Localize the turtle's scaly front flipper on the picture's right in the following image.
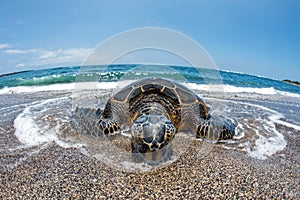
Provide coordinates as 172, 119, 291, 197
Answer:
196, 116, 236, 141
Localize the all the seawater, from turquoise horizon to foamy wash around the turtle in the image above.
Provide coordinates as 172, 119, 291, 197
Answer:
0, 65, 300, 170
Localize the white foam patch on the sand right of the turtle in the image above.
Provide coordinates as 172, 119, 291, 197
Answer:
225, 100, 300, 160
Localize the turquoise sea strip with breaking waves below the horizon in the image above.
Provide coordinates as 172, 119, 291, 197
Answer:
0, 64, 300, 94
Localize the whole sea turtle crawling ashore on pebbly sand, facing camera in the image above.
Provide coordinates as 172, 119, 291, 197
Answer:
74, 77, 235, 161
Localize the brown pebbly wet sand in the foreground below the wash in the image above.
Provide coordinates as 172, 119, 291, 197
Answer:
0, 123, 300, 199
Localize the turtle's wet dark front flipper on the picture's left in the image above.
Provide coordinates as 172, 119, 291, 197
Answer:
73, 108, 120, 137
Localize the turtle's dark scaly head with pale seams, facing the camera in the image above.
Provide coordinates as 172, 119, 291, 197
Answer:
131, 114, 176, 153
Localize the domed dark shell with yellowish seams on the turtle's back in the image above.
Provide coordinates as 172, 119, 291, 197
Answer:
111, 78, 208, 118
